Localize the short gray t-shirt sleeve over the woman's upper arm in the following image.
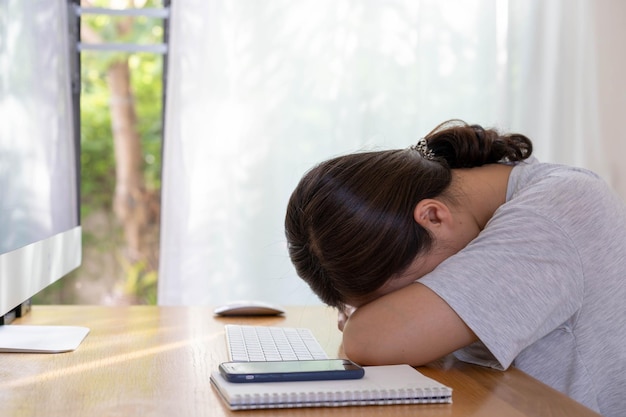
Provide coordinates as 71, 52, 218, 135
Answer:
418, 206, 584, 369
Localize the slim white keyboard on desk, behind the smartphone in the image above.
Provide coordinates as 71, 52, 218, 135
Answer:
224, 324, 328, 362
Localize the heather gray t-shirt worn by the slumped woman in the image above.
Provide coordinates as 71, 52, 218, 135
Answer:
419, 159, 626, 417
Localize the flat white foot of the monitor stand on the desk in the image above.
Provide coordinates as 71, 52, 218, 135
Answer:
0, 324, 89, 353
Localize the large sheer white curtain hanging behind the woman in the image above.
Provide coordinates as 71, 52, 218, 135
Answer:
159, 0, 626, 305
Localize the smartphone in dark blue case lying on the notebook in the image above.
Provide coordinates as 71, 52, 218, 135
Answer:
219, 359, 365, 382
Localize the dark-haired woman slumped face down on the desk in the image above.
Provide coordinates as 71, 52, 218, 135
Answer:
285, 121, 626, 416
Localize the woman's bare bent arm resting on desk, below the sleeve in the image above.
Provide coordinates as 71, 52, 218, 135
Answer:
343, 283, 477, 366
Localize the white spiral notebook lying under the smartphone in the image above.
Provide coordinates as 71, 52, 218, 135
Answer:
211, 365, 452, 410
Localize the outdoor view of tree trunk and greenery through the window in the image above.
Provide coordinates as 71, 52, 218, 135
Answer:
35, 0, 162, 303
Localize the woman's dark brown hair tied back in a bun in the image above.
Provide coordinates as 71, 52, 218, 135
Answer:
285, 120, 532, 308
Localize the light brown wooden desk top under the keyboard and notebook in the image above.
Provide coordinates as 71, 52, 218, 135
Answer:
0, 306, 598, 417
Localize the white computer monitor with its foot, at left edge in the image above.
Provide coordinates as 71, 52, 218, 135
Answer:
0, 0, 88, 351
